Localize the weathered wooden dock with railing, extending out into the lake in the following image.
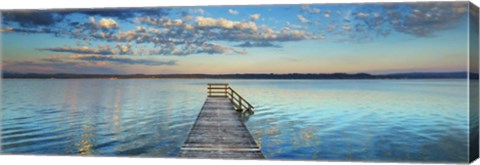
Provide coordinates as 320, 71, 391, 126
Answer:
180, 84, 264, 159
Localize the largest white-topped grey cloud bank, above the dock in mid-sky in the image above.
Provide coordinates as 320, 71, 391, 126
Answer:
104, 16, 309, 44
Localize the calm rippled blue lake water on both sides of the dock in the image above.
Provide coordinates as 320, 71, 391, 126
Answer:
1, 79, 468, 162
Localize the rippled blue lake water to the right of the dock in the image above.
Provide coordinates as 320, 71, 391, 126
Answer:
234, 80, 468, 162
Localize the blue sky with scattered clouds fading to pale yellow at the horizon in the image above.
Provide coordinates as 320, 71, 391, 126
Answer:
0, 2, 478, 74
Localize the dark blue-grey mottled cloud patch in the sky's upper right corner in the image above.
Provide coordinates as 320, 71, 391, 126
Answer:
355, 2, 468, 37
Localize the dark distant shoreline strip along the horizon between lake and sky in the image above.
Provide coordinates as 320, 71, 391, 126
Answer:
2, 72, 478, 80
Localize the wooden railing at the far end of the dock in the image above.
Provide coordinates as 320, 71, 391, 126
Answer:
207, 83, 254, 112
